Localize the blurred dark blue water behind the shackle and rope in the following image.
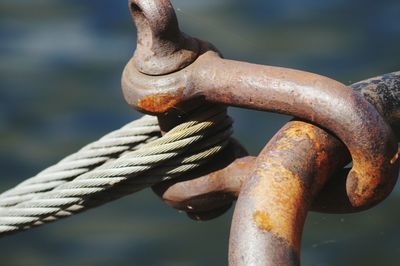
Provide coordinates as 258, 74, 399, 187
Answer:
0, 0, 400, 266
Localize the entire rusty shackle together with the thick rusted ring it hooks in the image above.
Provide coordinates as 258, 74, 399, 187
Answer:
122, 0, 400, 265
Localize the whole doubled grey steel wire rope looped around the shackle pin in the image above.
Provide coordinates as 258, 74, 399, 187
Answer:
0, 106, 232, 235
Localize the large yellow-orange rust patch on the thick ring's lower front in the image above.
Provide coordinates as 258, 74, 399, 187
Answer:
250, 163, 307, 250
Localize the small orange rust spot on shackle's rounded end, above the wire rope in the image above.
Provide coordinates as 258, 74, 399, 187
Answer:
137, 93, 181, 113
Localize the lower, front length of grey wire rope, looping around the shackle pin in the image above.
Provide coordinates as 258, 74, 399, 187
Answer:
0, 107, 232, 234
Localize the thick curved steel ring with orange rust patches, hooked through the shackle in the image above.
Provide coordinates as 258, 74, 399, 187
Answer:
229, 73, 400, 265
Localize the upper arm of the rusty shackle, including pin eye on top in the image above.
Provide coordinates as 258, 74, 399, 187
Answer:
122, 0, 398, 207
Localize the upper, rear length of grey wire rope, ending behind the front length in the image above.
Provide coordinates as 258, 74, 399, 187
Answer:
0, 116, 160, 207
